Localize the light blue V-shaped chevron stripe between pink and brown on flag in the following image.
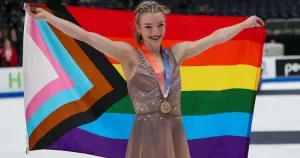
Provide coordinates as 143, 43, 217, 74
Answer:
27, 20, 92, 136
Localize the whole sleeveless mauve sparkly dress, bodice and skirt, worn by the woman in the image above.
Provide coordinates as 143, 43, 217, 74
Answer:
126, 49, 190, 158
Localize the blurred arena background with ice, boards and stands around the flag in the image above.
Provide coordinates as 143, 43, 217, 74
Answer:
0, 0, 300, 158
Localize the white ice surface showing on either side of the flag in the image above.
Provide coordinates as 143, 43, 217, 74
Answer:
0, 95, 300, 158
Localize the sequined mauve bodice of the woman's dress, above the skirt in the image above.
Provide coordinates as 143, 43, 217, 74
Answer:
127, 49, 181, 118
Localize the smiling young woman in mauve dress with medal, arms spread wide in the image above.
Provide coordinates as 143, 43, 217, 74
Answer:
25, 1, 264, 158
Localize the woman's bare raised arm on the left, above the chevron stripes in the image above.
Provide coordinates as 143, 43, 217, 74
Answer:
25, 5, 136, 65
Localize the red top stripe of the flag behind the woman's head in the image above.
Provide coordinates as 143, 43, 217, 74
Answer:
67, 6, 266, 42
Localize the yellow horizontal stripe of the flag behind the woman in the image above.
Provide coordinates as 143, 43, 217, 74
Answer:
114, 64, 260, 91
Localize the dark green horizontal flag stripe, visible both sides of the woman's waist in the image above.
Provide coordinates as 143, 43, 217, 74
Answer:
106, 89, 255, 116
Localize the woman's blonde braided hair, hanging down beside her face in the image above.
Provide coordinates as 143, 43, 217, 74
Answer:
133, 1, 164, 45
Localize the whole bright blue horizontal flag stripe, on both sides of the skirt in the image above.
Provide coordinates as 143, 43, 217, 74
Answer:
79, 113, 252, 140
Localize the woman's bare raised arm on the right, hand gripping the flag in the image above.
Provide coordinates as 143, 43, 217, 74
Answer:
172, 16, 264, 63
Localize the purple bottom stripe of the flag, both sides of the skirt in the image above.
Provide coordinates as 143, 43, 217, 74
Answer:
49, 129, 249, 158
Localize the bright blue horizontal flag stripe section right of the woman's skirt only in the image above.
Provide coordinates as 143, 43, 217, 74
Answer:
183, 112, 252, 140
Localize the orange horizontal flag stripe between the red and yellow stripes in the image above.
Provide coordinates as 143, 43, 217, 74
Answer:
105, 37, 263, 67
